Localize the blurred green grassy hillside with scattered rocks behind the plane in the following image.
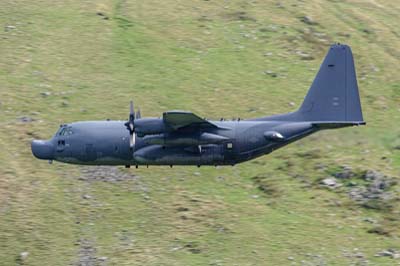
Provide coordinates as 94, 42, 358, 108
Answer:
0, 0, 400, 266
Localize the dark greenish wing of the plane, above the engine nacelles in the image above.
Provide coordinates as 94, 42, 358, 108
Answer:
163, 111, 217, 130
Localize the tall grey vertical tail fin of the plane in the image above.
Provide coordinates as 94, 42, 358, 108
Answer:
294, 44, 365, 124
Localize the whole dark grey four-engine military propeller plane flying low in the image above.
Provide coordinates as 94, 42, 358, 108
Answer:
31, 44, 365, 167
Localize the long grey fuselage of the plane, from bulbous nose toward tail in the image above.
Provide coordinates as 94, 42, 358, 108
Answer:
32, 120, 318, 166
